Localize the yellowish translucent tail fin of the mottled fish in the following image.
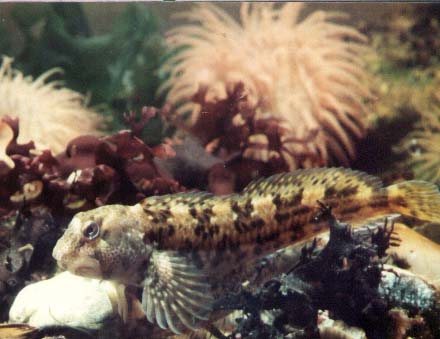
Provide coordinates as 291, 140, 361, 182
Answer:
386, 180, 440, 222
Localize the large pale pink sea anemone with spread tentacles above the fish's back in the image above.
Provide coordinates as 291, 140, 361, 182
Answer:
161, 3, 371, 169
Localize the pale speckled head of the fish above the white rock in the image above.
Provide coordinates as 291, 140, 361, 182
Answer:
53, 205, 152, 283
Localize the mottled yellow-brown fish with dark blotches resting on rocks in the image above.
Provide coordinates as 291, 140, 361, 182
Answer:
53, 168, 440, 333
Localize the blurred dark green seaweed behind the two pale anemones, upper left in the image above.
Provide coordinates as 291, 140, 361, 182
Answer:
0, 3, 165, 130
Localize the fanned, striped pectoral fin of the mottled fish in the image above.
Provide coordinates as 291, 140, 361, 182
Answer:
142, 251, 214, 334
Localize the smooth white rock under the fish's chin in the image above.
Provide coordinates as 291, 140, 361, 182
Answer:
9, 272, 124, 330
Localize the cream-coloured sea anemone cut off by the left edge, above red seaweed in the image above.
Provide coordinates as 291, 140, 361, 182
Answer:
0, 57, 101, 159
